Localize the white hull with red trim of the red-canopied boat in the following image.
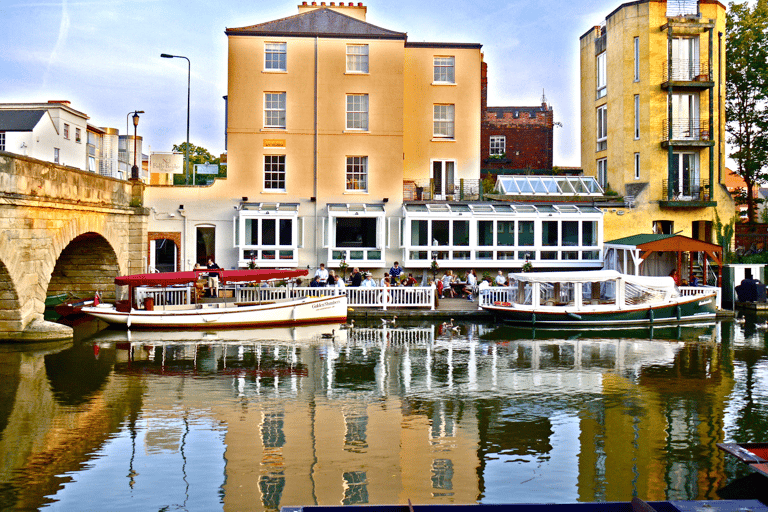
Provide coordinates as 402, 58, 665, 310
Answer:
82, 295, 347, 329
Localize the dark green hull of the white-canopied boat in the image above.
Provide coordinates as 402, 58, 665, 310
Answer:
483, 294, 717, 329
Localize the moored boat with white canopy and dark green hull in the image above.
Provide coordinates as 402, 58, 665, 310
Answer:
480, 270, 717, 329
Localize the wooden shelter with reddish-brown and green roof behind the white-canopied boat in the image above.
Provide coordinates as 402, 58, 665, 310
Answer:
604, 234, 723, 286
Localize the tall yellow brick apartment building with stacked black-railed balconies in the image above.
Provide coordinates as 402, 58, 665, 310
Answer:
580, 0, 734, 246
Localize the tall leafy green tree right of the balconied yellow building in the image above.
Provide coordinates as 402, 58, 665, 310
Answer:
725, 0, 768, 222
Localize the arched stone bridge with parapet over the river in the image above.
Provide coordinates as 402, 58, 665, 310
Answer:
0, 151, 148, 340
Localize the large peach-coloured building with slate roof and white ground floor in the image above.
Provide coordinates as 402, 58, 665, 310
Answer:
148, 2, 482, 269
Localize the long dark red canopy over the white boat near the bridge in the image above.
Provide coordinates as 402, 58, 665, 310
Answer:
115, 269, 309, 286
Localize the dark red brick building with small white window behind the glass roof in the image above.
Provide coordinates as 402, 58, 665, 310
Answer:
480, 63, 554, 174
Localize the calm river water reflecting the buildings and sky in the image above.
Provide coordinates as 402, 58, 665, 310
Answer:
0, 322, 768, 511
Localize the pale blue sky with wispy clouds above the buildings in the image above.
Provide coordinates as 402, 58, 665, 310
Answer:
0, 0, 622, 166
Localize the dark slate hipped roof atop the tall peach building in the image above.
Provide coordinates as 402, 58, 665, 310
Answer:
224, 7, 408, 40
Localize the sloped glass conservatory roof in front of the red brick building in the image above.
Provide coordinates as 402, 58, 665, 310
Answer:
496, 175, 603, 197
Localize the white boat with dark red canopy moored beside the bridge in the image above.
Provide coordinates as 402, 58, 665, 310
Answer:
81, 269, 347, 329
